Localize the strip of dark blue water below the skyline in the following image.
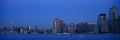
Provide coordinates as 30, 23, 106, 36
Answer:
0, 34, 120, 40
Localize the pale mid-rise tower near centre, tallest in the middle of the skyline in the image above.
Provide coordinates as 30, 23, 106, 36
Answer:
53, 18, 64, 33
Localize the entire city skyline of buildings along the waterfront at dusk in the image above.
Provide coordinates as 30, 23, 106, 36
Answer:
0, 6, 120, 34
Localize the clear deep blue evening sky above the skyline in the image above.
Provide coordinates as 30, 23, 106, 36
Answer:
0, 0, 120, 27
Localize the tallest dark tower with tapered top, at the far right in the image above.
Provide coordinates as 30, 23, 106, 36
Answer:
108, 6, 119, 33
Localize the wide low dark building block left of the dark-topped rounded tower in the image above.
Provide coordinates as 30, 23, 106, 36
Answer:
76, 22, 98, 34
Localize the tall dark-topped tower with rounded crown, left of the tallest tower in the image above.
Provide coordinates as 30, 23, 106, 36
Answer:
97, 13, 109, 33
